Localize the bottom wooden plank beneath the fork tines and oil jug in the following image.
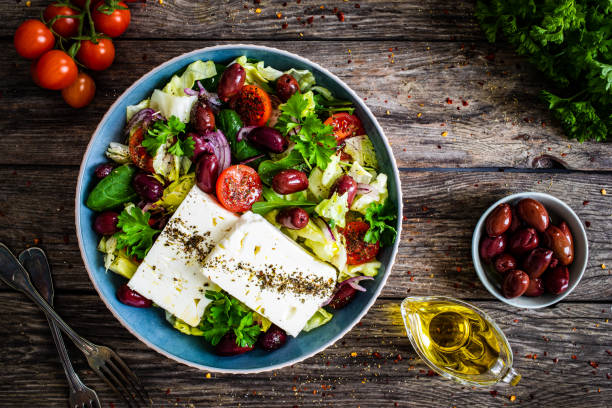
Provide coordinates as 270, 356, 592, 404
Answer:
0, 293, 612, 408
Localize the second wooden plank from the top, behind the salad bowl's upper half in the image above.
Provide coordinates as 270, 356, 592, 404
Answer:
0, 41, 612, 170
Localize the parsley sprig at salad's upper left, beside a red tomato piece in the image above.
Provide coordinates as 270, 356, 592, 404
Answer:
142, 115, 195, 157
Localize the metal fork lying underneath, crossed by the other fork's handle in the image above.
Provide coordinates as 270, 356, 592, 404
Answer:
19, 247, 102, 408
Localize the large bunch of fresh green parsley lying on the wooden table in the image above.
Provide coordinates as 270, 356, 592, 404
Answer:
475, 0, 612, 142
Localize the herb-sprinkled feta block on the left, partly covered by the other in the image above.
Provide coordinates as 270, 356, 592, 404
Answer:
128, 186, 239, 326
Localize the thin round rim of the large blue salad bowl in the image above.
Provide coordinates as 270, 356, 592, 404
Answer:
74, 44, 403, 374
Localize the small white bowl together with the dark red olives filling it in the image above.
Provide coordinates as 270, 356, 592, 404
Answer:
472, 192, 588, 308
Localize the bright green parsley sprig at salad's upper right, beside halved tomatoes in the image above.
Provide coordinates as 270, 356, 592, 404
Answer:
276, 92, 337, 169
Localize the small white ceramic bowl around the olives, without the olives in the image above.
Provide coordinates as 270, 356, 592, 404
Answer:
472, 192, 589, 309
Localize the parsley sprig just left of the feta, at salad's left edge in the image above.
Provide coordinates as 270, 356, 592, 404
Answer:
115, 204, 161, 259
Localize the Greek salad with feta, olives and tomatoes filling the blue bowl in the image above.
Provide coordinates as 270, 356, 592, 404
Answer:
86, 56, 396, 356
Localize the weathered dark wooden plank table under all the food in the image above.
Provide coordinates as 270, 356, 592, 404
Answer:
0, 0, 612, 407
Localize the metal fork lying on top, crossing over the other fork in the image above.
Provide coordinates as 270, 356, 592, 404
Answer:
0, 243, 151, 408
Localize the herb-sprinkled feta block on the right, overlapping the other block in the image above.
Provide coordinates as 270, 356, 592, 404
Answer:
202, 212, 336, 336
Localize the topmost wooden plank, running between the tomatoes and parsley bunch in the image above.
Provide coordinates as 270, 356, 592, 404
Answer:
0, 0, 483, 41
